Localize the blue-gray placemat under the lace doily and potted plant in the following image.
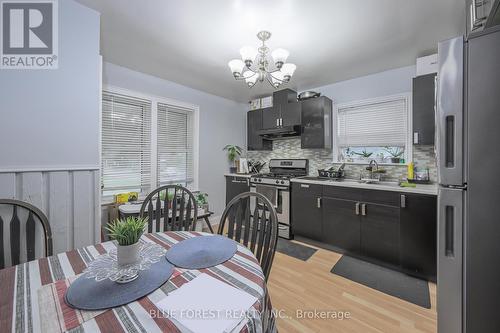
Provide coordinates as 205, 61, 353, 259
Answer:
64, 258, 174, 310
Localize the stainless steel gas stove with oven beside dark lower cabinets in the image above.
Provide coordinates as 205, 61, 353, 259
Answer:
250, 159, 309, 239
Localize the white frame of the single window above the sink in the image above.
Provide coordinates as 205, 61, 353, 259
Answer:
332, 92, 413, 165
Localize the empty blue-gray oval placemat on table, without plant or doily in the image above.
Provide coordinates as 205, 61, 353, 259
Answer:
166, 235, 237, 269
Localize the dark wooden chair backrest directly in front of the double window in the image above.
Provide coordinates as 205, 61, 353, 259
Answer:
139, 185, 198, 232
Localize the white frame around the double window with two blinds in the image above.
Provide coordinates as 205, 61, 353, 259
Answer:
99, 85, 200, 202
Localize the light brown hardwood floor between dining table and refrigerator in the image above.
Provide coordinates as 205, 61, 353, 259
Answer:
268, 239, 437, 333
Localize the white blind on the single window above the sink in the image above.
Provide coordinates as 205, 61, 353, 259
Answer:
337, 97, 408, 147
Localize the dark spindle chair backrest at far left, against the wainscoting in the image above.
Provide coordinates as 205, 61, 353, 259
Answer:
0, 199, 52, 269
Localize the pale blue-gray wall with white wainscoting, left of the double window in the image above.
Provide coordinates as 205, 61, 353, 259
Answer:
0, 0, 101, 253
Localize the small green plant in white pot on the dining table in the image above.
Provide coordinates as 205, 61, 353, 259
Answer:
106, 216, 148, 265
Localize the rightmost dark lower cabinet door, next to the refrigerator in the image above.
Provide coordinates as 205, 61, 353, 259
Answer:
400, 193, 437, 281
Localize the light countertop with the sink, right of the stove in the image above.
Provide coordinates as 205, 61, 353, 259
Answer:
291, 178, 438, 195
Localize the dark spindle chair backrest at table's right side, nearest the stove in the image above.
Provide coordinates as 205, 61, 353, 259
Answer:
218, 192, 278, 280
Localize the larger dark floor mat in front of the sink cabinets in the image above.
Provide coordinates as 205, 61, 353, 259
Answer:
331, 256, 431, 309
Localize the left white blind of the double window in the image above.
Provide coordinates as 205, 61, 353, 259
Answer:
101, 91, 151, 194
